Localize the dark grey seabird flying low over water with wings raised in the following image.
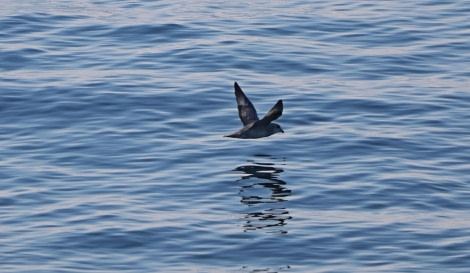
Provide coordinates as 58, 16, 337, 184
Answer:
226, 82, 284, 138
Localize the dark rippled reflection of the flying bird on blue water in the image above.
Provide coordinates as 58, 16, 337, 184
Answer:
235, 155, 292, 233
